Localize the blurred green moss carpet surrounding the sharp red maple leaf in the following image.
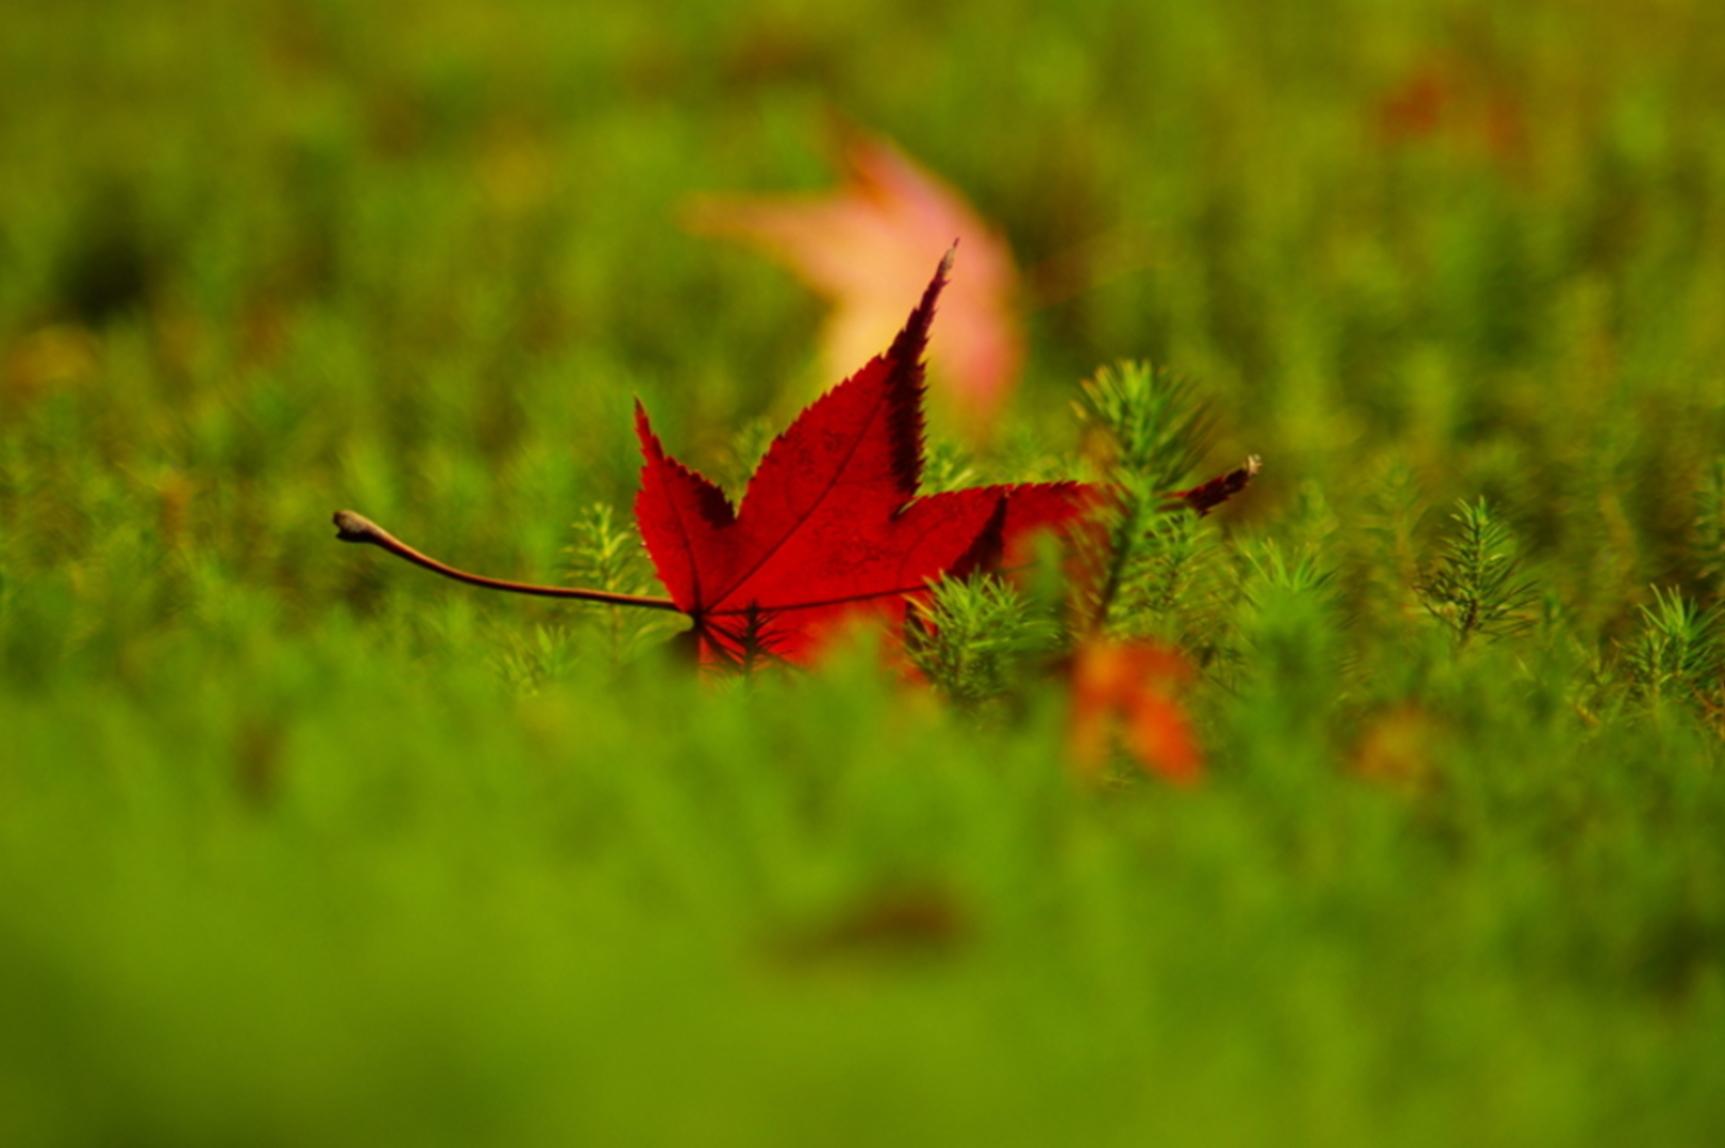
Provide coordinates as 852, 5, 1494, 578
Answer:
0, 0, 1725, 1145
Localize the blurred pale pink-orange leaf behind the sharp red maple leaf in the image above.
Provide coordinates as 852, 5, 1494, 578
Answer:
688, 134, 1025, 440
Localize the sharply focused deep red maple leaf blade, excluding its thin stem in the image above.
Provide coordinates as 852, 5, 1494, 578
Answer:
635, 252, 1092, 664
